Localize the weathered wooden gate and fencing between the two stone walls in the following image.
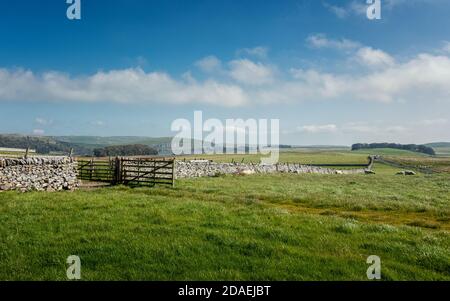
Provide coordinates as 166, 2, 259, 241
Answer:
78, 157, 175, 186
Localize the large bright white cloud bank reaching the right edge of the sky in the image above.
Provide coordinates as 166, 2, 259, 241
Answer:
284, 54, 450, 102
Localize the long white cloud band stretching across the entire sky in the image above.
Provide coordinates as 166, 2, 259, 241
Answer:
0, 48, 450, 107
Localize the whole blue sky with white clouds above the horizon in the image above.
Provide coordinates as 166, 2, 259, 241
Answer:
0, 0, 450, 145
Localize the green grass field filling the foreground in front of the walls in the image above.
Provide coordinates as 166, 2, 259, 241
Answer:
0, 164, 450, 280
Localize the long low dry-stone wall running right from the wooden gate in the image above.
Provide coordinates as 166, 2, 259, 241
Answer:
175, 161, 370, 178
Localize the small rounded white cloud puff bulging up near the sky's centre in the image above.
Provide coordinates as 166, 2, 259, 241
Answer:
229, 59, 274, 85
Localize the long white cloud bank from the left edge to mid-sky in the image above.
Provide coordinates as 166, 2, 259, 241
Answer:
0, 68, 248, 106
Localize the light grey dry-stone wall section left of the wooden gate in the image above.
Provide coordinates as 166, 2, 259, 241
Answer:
0, 157, 79, 192
